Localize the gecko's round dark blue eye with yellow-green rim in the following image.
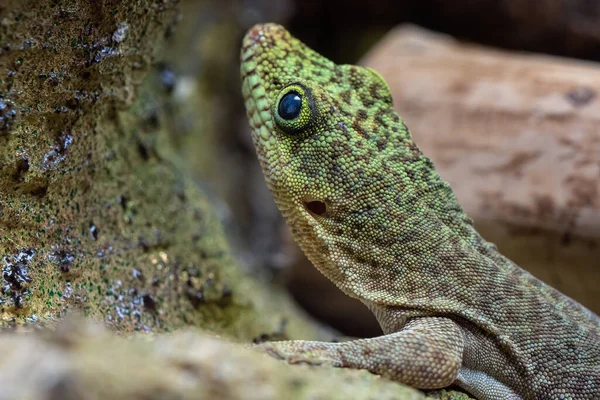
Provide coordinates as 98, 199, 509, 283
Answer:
273, 83, 315, 135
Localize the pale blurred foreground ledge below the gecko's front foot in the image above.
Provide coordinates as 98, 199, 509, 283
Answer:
0, 323, 432, 400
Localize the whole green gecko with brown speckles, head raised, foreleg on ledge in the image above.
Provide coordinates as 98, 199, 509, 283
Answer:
241, 24, 600, 400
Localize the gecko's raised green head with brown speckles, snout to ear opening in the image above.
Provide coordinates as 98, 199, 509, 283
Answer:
241, 24, 418, 297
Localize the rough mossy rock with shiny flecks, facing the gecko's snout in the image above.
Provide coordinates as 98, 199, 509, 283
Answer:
0, 0, 316, 340
